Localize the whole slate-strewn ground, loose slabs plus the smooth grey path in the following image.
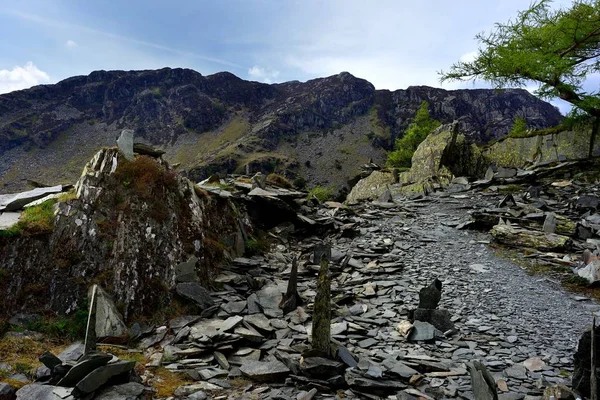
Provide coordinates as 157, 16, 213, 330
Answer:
137, 193, 600, 400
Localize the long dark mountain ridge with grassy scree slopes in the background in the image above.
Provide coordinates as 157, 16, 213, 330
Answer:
0, 68, 560, 192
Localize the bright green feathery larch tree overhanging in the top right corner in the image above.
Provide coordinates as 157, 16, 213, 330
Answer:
440, 0, 600, 151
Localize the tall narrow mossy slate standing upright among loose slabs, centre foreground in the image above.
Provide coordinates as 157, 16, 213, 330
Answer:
311, 257, 331, 354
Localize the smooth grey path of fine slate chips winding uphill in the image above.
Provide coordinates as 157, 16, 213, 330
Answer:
336, 194, 600, 398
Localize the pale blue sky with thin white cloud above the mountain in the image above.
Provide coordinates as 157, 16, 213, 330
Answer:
0, 0, 584, 110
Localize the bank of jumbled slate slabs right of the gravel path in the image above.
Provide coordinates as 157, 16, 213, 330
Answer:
451, 162, 600, 284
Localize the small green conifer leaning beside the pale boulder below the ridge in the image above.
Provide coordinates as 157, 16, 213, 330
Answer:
386, 101, 441, 168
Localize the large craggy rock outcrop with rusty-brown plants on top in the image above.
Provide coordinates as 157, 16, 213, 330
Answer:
0, 148, 249, 318
